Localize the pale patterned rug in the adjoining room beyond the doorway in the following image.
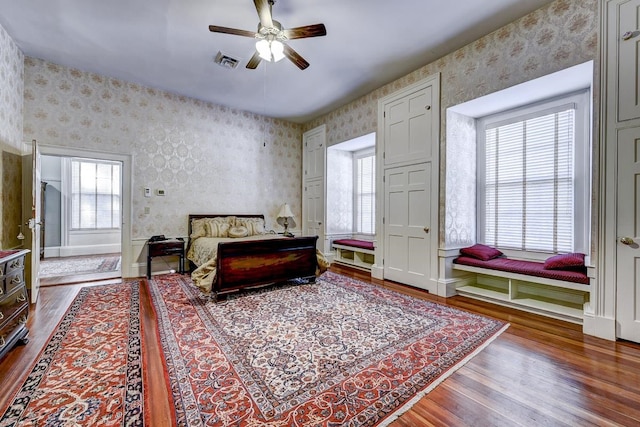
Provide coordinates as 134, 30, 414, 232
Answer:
40, 254, 120, 277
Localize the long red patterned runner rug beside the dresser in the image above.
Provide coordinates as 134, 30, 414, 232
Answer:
0, 281, 144, 426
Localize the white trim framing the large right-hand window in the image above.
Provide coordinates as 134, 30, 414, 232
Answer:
476, 89, 591, 259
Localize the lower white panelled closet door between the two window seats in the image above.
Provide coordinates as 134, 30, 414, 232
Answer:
383, 163, 437, 293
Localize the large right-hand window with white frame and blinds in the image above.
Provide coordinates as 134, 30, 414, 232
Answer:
477, 91, 590, 253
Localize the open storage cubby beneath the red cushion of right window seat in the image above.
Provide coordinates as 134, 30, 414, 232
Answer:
454, 265, 590, 324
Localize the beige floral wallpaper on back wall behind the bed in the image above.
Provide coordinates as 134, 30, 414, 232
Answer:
24, 57, 302, 239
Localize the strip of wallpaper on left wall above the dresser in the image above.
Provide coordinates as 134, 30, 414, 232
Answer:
0, 22, 24, 249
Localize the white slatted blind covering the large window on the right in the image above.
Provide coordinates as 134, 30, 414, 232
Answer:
484, 105, 575, 252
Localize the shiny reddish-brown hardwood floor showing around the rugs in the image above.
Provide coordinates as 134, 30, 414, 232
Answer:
0, 266, 640, 427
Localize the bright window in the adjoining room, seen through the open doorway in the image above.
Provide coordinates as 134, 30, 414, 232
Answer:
71, 159, 121, 230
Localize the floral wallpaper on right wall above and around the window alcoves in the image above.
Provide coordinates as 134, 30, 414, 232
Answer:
304, 0, 600, 248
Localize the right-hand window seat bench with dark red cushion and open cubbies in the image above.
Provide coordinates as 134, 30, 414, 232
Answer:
453, 256, 591, 324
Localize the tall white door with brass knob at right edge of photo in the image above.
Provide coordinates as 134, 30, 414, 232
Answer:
616, 128, 640, 342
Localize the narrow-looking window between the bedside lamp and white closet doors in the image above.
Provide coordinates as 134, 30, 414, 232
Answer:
354, 149, 376, 234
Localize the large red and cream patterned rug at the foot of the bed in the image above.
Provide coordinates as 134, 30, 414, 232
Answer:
149, 272, 508, 427
